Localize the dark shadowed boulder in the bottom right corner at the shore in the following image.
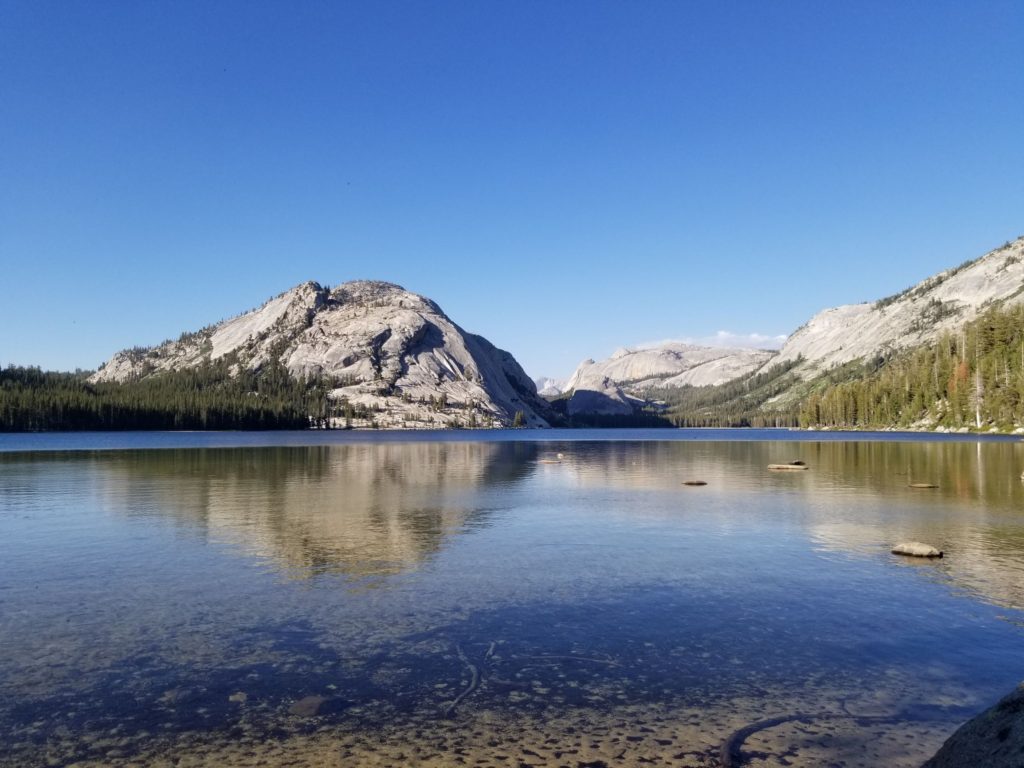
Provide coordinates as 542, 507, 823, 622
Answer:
922, 683, 1024, 768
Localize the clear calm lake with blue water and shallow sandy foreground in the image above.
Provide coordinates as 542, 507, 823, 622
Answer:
0, 430, 1024, 768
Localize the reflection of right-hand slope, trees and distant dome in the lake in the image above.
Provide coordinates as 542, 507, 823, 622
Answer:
528, 441, 1024, 609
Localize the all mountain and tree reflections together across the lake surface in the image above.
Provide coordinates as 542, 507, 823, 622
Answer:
29, 441, 1024, 608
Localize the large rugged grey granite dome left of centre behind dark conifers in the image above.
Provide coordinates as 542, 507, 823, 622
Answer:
91, 281, 548, 428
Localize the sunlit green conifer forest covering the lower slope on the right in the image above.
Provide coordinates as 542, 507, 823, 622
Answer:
622, 304, 1024, 431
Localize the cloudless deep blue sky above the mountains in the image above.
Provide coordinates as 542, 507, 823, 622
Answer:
0, 0, 1024, 376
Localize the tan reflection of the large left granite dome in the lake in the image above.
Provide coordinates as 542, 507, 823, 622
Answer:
96, 443, 536, 579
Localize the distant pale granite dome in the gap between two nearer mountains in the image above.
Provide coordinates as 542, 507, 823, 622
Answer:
562, 342, 775, 416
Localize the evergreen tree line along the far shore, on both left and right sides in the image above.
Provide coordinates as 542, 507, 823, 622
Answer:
8, 304, 1024, 431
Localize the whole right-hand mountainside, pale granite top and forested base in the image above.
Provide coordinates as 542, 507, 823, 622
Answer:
664, 238, 1024, 431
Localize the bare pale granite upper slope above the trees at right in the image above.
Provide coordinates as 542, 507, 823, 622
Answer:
771, 238, 1024, 378
